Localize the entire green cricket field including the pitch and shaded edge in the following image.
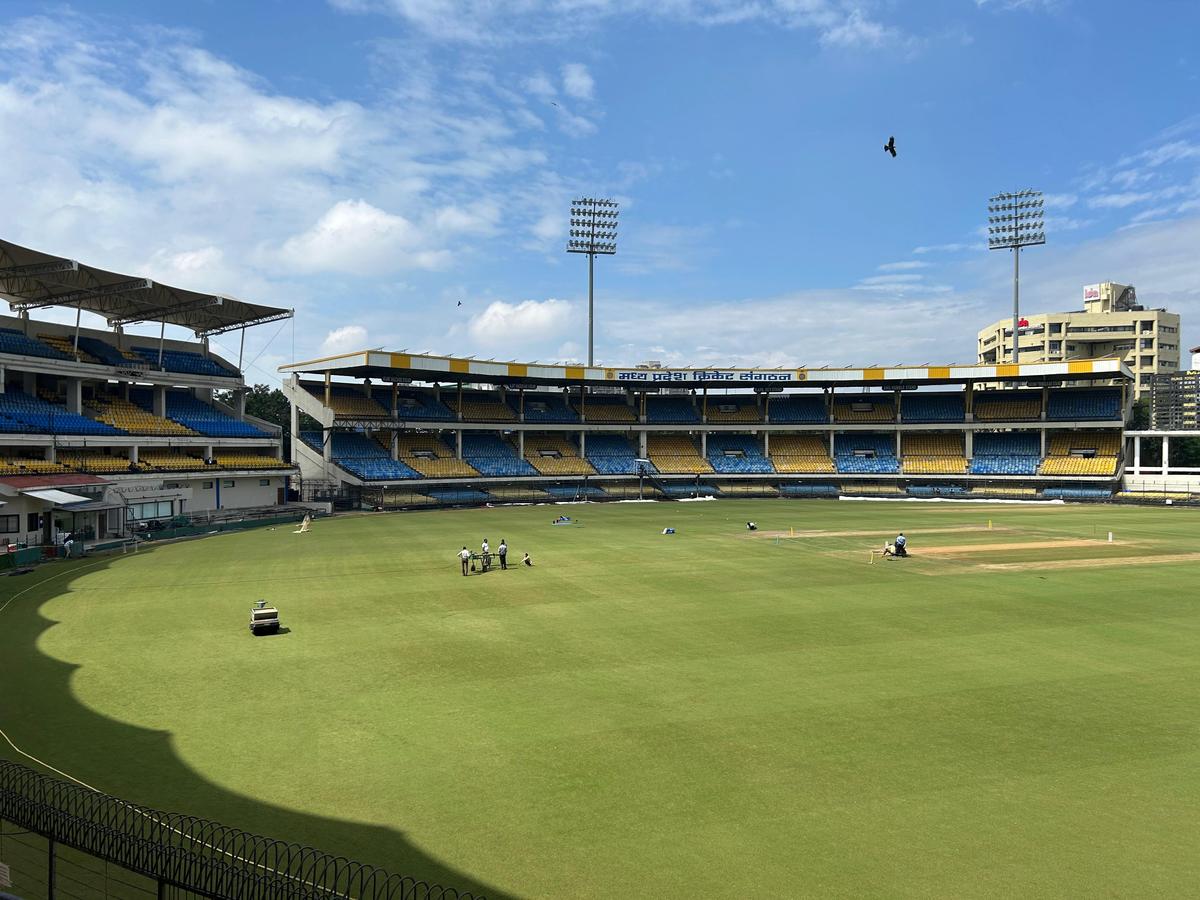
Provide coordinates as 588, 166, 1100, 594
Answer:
0, 500, 1200, 898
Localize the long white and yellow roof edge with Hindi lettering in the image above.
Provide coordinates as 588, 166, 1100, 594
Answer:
280, 350, 1133, 390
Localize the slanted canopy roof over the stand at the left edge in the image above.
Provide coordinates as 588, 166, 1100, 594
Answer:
0, 240, 293, 337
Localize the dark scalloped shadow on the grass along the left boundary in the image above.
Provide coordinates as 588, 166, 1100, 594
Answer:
0, 557, 514, 900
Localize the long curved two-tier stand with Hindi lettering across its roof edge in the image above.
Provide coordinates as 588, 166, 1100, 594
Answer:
281, 350, 1133, 506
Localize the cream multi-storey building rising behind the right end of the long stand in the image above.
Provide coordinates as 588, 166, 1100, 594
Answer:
978, 282, 1181, 398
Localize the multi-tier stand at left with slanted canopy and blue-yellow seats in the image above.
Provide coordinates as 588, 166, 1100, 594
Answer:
0, 241, 296, 547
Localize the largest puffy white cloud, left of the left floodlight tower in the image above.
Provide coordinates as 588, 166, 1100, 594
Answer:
280, 199, 450, 275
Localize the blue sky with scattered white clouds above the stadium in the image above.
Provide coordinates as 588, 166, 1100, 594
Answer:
0, 0, 1200, 380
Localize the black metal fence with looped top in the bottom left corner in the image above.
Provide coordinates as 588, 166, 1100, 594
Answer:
0, 761, 481, 900
